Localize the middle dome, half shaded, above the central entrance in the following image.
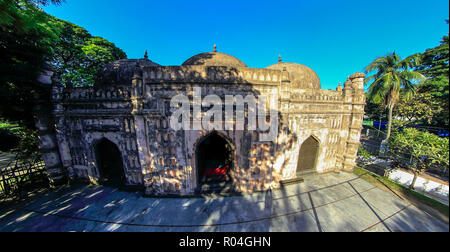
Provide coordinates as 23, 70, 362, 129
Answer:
182, 52, 247, 67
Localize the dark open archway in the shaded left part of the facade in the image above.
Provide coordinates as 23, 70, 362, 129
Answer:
95, 138, 125, 187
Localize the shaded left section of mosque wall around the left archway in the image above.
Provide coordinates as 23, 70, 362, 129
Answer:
53, 83, 142, 184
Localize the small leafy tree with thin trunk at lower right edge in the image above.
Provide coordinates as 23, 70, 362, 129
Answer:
388, 128, 449, 189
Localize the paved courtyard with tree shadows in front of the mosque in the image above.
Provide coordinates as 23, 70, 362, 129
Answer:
0, 173, 449, 232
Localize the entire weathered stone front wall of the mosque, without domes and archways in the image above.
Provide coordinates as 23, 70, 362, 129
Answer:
53, 62, 365, 194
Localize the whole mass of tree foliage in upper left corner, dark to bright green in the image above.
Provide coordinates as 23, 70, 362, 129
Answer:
0, 0, 126, 129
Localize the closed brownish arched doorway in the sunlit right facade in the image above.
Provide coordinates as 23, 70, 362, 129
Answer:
296, 136, 319, 176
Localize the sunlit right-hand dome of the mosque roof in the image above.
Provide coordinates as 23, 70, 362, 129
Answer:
266, 62, 321, 89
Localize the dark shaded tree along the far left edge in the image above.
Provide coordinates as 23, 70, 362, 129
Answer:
0, 0, 58, 129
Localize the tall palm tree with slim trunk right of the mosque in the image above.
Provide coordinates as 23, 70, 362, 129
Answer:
364, 52, 425, 143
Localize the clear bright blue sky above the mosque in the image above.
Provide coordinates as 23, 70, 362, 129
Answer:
44, 0, 449, 89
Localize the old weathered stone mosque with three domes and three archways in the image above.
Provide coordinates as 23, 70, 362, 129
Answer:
36, 47, 365, 195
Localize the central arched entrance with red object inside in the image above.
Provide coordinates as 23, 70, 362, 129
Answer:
196, 132, 234, 191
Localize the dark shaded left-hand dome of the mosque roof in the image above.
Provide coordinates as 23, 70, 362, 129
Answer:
95, 58, 160, 86
